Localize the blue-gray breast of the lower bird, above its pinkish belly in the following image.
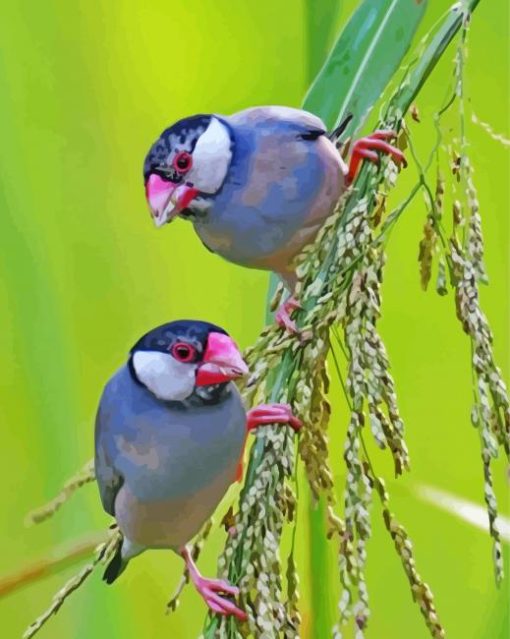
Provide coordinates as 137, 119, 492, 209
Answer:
98, 369, 246, 502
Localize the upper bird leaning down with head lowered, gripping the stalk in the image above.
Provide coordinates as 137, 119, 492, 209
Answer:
143, 106, 405, 332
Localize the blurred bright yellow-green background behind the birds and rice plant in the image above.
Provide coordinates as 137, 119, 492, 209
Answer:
0, 0, 510, 639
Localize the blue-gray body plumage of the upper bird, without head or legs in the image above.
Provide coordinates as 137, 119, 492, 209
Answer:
191, 107, 347, 282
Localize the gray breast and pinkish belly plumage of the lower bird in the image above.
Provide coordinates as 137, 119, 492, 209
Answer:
95, 365, 246, 552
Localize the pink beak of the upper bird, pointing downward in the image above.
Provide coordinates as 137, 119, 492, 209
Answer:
145, 173, 198, 227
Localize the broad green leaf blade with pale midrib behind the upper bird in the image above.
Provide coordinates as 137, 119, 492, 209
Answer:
303, 0, 427, 135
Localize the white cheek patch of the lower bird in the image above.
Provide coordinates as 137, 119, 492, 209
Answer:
133, 351, 196, 401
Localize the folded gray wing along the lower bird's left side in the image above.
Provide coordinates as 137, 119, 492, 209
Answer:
94, 385, 124, 516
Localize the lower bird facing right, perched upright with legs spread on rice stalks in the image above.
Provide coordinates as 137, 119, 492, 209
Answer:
94, 320, 301, 620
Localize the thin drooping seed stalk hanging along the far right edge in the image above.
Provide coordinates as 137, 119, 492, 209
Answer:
415, 16, 510, 584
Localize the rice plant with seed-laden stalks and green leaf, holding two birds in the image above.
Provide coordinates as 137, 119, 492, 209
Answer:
1, 0, 510, 639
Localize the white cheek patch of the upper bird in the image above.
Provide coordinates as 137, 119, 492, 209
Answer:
186, 117, 232, 194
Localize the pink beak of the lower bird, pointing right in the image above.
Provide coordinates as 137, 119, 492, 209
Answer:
196, 333, 249, 386
